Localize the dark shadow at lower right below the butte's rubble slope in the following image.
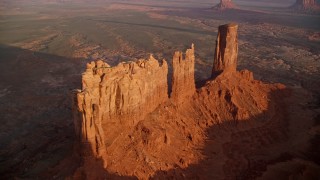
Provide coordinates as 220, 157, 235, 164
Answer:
152, 89, 320, 179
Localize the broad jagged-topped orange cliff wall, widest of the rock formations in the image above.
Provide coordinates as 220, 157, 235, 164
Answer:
73, 56, 168, 165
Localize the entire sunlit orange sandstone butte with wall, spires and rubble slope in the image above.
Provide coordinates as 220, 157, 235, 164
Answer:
73, 24, 285, 179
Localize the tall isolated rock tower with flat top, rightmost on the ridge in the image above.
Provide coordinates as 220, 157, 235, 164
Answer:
212, 24, 238, 77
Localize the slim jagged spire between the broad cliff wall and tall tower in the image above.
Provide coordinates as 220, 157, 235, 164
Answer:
170, 44, 196, 104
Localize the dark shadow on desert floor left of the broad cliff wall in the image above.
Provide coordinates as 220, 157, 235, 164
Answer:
0, 45, 85, 178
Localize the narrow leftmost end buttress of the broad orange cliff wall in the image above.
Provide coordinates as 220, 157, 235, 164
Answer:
73, 62, 107, 164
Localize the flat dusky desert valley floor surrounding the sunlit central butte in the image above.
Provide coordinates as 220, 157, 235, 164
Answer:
0, 0, 320, 179
